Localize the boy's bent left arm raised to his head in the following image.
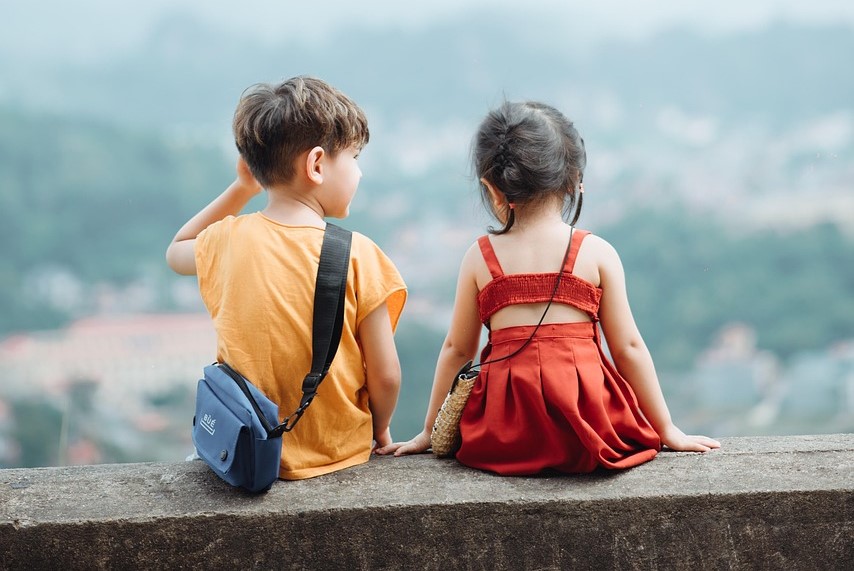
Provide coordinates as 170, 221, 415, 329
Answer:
166, 157, 263, 276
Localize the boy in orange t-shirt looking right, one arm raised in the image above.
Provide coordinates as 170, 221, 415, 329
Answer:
166, 77, 406, 479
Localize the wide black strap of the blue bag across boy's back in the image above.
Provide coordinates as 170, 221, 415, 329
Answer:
271, 223, 353, 436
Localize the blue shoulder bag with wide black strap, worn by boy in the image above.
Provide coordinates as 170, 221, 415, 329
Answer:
193, 224, 352, 492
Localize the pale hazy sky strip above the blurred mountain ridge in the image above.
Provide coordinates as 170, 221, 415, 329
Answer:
5, 0, 854, 59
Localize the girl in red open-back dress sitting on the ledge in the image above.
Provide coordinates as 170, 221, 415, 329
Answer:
377, 102, 720, 475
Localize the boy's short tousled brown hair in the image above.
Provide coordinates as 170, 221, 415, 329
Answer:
232, 76, 370, 188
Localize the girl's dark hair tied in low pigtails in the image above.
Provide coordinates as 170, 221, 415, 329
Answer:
472, 101, 587, 234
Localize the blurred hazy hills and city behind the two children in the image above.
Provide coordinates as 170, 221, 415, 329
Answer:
0, 0, 854, 467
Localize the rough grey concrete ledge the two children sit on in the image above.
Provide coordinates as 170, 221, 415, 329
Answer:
0, 435, 854, 569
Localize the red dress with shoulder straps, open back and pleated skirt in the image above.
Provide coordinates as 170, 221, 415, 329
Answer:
457, 230, 661, 475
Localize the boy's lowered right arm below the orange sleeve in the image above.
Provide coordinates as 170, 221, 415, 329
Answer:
358, 303, 400, 454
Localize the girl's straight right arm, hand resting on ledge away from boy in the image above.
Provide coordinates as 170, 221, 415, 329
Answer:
590, 236, 720, 452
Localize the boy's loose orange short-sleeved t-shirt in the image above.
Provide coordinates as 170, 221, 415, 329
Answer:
195, 212, 406, 480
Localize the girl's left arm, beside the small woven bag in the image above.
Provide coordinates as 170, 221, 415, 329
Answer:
377, 246, 482, 456
